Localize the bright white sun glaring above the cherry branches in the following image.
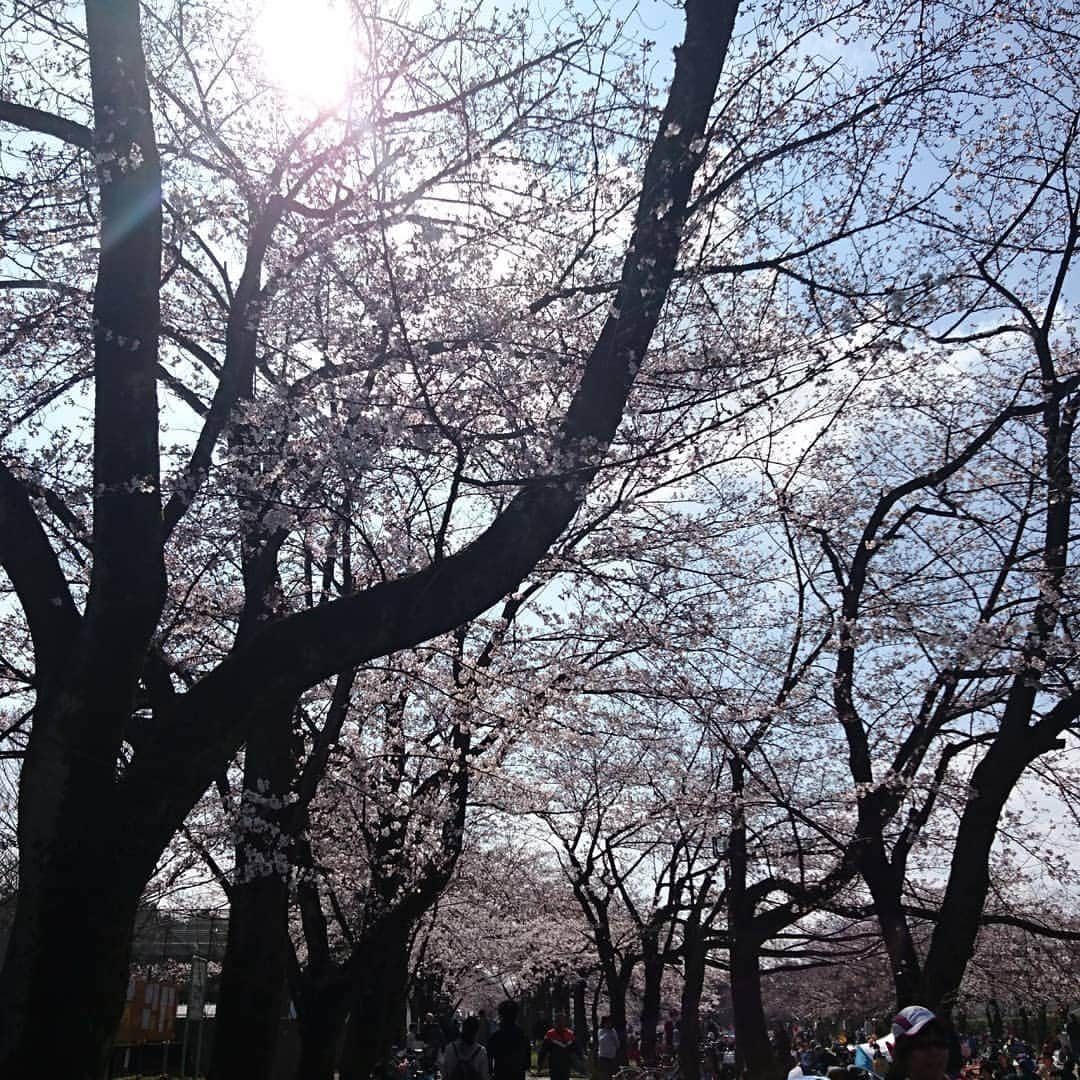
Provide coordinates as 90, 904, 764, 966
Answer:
255, 0, 356, 109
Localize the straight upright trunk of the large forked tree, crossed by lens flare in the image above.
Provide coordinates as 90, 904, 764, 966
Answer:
0, 0, 165, 1080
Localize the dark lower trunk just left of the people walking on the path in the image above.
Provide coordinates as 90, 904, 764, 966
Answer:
341, 915, 410, 1080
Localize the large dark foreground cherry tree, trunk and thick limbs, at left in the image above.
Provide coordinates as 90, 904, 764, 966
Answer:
0, 0, 735, 1077
